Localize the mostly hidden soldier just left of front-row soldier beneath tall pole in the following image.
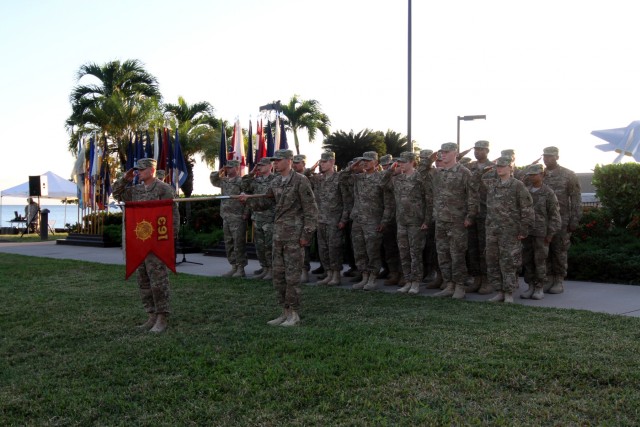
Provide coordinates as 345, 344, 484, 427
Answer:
379, 154, 404, 286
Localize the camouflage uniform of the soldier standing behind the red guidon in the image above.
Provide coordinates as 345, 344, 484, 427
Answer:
113, 178, 180, 315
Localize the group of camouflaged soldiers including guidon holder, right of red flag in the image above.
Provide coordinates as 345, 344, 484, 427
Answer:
220, 141, 581, 326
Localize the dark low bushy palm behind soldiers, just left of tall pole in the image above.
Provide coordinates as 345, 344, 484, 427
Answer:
322, 129, 387, 169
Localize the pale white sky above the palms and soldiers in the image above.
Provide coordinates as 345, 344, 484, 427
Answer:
0, 0, 640, 204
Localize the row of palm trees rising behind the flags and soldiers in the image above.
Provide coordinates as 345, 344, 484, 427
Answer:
66, 60, 416, 197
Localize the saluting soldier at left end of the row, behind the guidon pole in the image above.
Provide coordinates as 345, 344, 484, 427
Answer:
209, 160, 249, 277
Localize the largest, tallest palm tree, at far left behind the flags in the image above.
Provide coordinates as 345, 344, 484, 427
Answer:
66, 60, 161, 165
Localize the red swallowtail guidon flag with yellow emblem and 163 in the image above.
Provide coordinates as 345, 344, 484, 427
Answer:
124, 199, 176, 279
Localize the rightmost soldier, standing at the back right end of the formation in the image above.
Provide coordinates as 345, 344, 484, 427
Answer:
542, 147, 582, 294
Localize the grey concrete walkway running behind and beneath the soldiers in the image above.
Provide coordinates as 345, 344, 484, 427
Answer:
0, 241, 640, 317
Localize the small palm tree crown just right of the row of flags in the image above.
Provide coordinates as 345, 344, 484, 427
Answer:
282, 95, 331, 154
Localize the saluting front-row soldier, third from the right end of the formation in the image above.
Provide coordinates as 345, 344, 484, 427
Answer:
485, 157, 534, 303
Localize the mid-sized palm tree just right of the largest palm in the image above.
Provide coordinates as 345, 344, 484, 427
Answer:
163, 96, 219, 197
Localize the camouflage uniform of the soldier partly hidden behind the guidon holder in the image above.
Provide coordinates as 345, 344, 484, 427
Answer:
242, 174, 276, 269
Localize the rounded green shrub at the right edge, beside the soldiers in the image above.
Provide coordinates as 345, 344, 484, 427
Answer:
592, 163, 640, 227
